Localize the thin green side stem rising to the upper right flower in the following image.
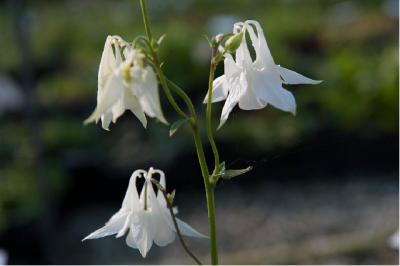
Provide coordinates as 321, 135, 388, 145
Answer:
206, 51, 219, 174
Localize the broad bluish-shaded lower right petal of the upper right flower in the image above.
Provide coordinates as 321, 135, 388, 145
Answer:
253, 71, 296, 114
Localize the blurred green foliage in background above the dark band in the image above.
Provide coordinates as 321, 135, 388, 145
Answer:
0, 0, 399, 237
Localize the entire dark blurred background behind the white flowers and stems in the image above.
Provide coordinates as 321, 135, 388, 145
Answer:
0, 0, 399, 264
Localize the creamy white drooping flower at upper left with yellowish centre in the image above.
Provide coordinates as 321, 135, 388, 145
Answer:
85, 36, 168, 130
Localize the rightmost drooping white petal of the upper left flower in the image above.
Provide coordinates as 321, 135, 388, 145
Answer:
133, 66, 168, 124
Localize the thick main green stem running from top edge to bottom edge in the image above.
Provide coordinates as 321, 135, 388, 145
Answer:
140, 0, 219, 265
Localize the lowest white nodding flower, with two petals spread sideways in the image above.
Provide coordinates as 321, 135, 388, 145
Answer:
82, 167, 206, 258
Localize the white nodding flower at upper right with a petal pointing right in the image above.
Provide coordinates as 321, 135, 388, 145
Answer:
204, 20, 321, 127
